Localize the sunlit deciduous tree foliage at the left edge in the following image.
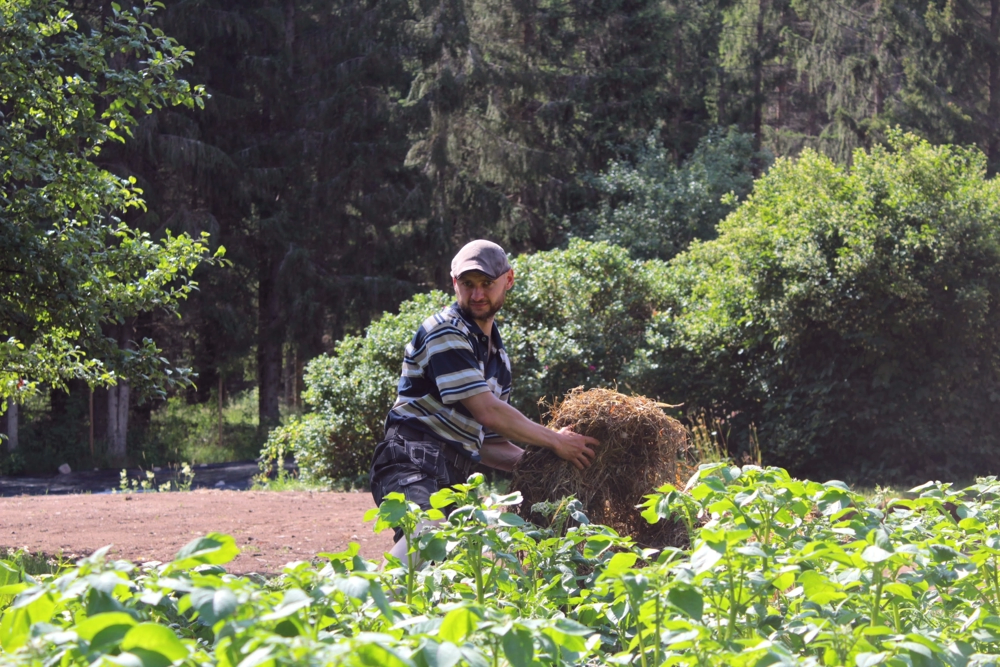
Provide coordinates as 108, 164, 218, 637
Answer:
0, 0, 215, 408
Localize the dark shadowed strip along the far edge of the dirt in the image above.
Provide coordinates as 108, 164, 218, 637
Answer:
0, 461, 296, 497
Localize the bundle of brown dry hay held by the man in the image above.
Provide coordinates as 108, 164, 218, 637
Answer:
511, 389, 687, 547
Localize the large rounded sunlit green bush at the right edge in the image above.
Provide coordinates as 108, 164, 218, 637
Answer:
644, 132, 1000, 480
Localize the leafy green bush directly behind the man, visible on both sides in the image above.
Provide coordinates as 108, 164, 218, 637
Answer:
262, 241, 664, 483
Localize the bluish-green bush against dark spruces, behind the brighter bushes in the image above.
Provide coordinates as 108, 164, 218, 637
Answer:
577, 128, 770, 259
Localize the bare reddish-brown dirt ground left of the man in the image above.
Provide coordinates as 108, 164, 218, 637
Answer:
0, 490, 392, 574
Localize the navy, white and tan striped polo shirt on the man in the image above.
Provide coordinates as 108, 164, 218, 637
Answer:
386, 304, 511, 461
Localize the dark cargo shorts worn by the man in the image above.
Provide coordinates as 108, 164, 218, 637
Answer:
368, 433, 469, 542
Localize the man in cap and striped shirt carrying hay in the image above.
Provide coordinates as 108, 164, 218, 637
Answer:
370, 240, 598, 559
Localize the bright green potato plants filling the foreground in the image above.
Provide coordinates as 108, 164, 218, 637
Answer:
0, 464, 1000, 667
